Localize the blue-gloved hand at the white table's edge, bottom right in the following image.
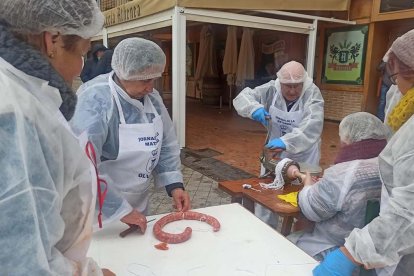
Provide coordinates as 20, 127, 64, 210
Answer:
312, 248, 357, 276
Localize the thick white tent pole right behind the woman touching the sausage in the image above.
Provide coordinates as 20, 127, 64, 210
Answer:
172, 6, 187, 147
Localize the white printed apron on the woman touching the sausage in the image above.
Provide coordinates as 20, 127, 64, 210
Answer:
99, 73, 163, 214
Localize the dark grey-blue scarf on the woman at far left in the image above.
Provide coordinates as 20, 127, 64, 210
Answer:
0, 21, 77, 121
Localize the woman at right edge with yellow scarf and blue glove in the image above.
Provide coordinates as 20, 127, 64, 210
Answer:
314, 30, 414, 276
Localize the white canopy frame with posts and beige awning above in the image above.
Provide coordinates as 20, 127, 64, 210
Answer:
94, 0, 355, 147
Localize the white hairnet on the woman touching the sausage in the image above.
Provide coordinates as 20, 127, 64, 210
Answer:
112, 37, 166, 80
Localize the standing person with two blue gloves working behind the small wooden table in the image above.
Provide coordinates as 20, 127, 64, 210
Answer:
233, 61, 324, 227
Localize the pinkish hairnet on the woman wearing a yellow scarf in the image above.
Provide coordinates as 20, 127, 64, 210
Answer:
390, 30, 414, 69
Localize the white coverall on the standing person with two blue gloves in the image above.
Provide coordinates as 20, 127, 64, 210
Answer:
233, 77, 324, 165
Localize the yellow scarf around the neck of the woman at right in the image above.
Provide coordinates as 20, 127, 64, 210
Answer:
387, 88, 414, 132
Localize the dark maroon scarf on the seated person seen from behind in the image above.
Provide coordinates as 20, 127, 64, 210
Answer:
334, 139, 387, 164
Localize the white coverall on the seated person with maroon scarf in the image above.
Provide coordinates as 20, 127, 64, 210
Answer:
295, 158, 381, 257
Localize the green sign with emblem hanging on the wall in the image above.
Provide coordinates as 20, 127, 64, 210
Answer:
322, 26, 368, 85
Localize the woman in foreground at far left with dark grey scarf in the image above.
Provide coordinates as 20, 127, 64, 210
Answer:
0, 0, 113, 275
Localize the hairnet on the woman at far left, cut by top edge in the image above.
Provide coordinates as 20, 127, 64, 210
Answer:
0, 0, 104, 38
